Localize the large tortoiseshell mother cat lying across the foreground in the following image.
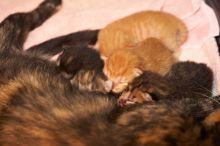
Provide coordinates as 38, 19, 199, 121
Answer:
0, 0, 219, 146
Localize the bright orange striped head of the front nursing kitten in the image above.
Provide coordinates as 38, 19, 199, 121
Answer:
103, 49, 143, 93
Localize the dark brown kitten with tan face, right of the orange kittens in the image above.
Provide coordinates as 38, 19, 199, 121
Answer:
119, 62, 220, 121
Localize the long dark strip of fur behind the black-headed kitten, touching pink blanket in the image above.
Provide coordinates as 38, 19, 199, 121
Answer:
26, 30, 99, 59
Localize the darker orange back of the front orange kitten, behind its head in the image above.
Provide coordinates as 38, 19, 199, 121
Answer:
135, 38, 176, 75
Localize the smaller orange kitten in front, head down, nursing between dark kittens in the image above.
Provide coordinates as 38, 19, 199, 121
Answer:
103, 38, 176, 93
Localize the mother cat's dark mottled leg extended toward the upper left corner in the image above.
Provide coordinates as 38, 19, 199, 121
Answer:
0, 0, 62, 52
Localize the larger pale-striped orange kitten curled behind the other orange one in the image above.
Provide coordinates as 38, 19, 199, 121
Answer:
98, 11, 187, 57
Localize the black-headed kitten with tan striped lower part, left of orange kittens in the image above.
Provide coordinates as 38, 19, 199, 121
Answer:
58, 46, 110, 93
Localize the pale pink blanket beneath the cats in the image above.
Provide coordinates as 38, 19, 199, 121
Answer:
0, 0, 220, 95
